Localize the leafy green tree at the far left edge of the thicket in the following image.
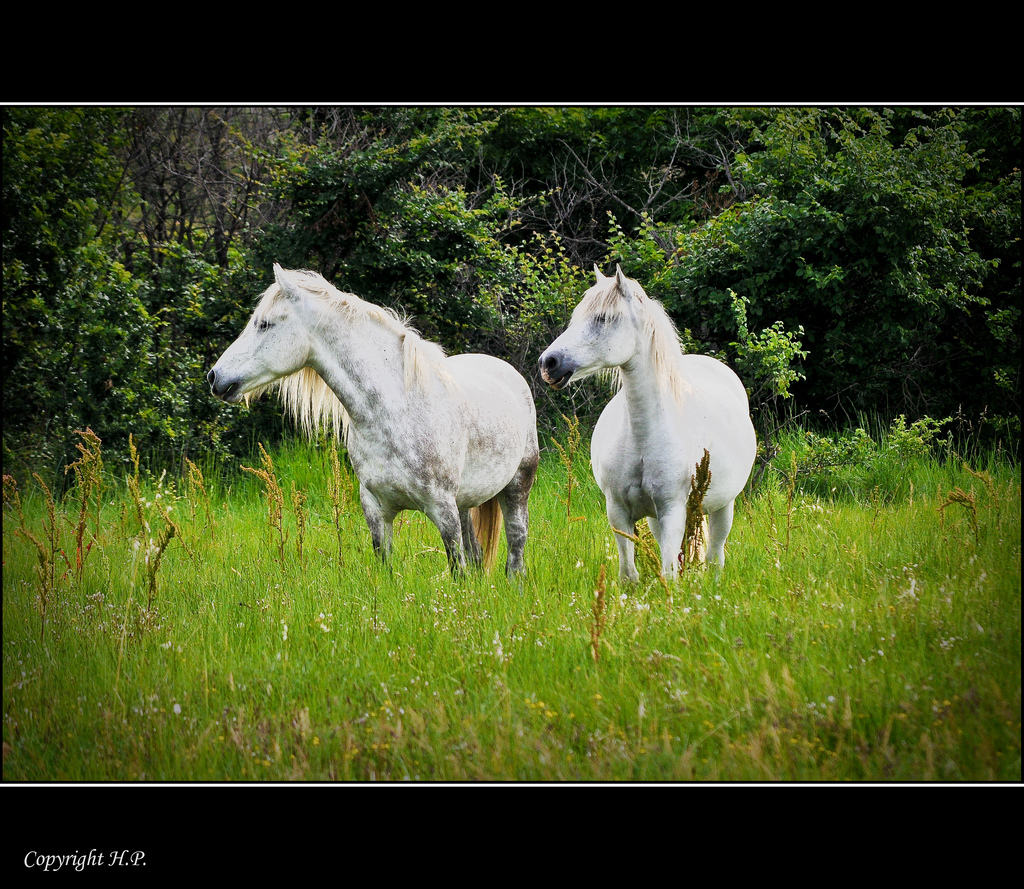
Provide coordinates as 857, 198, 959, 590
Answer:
3, 108, 148, 483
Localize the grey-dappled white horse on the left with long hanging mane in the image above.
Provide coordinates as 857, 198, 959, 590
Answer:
207, 264, 540, 575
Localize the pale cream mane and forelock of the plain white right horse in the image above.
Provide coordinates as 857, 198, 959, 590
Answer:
572, 277, 687, 400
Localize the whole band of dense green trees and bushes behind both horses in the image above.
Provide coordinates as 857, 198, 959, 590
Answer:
3, 107, 1021, 489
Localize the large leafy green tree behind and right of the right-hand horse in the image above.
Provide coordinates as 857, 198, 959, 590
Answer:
606, 109, 1006, 434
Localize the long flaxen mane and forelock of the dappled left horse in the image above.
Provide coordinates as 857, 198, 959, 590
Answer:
246, 270, 453, 440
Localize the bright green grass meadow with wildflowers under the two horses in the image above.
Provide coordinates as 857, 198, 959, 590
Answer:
3, 428, 1021, 782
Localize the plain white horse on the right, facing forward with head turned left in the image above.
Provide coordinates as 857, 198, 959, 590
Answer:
541, 266, 757, 581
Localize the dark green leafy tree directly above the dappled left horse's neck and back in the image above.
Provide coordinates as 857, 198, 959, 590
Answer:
259, 109, 517, 351
